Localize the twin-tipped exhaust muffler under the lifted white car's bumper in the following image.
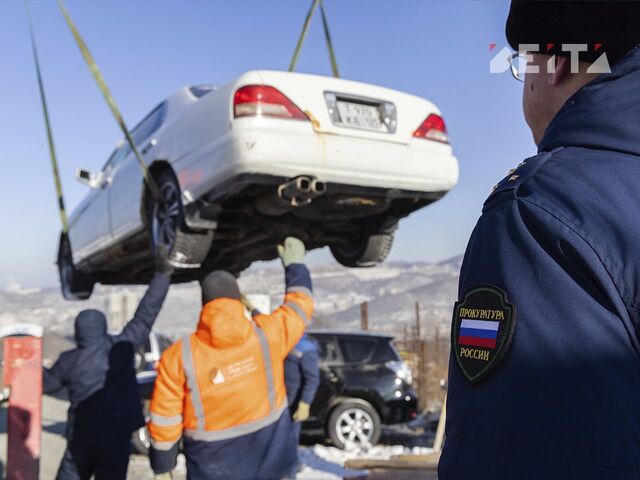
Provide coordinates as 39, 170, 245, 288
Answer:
256, 175, 327, 217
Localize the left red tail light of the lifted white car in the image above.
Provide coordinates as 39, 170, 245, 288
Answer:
233, 85, 309, 120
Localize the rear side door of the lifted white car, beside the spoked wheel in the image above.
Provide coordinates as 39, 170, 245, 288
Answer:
109, 103, 166, 242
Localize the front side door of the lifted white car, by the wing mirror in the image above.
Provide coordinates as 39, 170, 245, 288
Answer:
69, 145, 126, 264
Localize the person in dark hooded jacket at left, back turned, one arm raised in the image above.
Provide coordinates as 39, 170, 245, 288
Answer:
43, 250, 173, 480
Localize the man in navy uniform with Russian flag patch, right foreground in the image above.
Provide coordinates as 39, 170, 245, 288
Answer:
439, 1, 640, 480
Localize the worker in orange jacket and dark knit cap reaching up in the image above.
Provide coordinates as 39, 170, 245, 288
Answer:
149, 237, 313, 480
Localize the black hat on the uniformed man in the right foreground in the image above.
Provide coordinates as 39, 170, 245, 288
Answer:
506, 0, 640, 65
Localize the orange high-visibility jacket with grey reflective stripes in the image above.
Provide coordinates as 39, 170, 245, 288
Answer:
149, 264, 313, 473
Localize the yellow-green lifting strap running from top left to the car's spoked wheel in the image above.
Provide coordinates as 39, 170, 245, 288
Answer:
58, 0, 162, 202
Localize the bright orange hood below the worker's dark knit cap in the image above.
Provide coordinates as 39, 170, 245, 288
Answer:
196, 298, 252, 348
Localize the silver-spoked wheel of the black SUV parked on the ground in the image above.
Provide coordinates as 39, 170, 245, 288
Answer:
327, 399, 381, 448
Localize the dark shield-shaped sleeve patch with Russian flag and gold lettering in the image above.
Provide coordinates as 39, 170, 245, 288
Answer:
451, 285, 516, 383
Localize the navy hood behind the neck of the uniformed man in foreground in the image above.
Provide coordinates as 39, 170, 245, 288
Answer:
538, 46, 640, 155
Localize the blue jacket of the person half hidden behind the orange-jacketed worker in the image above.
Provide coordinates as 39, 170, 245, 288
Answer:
284, 335, 320, 412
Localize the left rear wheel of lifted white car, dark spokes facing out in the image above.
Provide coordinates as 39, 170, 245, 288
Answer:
149, 170, 213, 268
